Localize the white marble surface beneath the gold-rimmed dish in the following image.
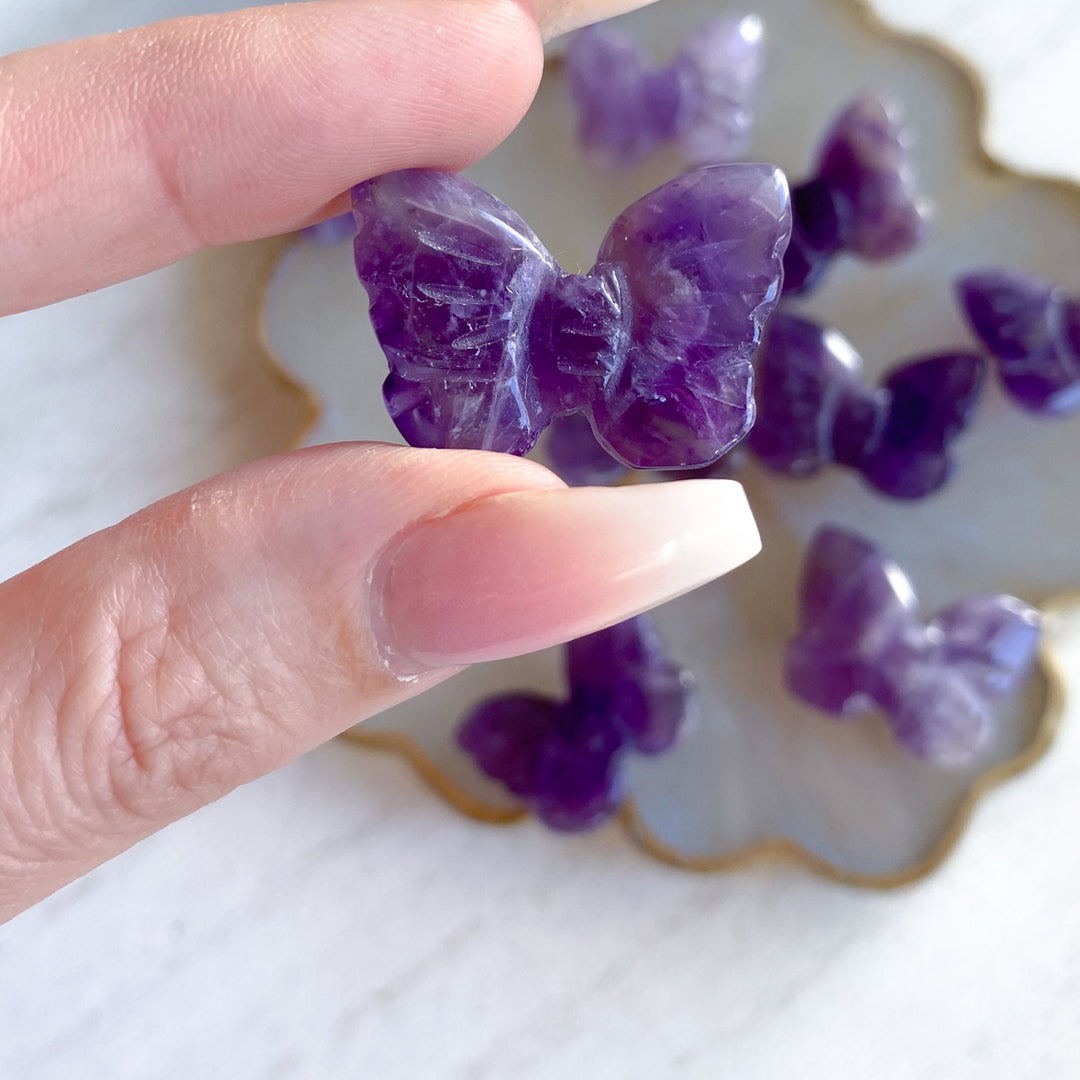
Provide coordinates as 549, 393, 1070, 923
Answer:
0, 0, 1080, 1080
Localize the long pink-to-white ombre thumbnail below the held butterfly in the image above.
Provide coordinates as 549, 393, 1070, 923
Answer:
372, 480, 760, 676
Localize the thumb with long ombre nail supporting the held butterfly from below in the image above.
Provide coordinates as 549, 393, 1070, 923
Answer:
0, 444, 758, 916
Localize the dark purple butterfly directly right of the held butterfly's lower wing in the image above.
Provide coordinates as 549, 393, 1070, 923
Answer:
747, 312, 986, 499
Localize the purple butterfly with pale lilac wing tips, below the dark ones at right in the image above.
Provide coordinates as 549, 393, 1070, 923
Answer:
785, 528, 1039, 767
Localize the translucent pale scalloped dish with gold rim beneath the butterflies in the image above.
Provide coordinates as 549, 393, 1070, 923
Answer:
265, 0, 1080, 887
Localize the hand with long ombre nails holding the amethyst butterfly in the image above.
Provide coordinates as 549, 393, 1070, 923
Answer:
0, 0, 758, 917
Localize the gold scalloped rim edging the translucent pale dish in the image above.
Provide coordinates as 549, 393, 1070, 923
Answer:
247, 0, 1080, 890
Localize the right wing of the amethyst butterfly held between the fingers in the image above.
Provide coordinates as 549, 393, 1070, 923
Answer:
592, 164, 791, 469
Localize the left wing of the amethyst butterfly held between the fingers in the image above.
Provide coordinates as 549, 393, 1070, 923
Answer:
352, 170, 556, 454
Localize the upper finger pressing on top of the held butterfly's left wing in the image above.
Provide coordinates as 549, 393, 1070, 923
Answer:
0, 0, 541, 314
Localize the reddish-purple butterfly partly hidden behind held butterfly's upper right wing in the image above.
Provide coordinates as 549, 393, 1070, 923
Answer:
784, 97, 928, 295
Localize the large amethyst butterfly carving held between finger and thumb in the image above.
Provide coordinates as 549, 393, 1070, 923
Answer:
353, 165, 791, 469
